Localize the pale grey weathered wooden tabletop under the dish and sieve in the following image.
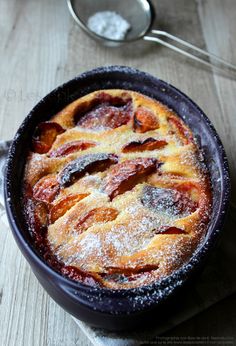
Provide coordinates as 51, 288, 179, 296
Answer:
0, 0, 236, 346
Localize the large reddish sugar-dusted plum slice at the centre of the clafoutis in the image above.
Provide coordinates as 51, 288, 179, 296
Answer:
103, 158, 157, 199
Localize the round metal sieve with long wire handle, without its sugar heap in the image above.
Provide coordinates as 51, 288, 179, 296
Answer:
67, 0, 236, 71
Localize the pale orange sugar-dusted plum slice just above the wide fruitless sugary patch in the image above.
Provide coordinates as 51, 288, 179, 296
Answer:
75, 207, 118, 233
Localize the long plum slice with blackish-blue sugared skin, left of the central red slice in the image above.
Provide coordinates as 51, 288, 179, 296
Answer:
58, 153, 118, 186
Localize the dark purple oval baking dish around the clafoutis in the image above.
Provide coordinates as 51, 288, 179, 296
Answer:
5, 66, 230, 330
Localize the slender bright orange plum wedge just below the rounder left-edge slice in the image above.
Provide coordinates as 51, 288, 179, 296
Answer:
49, 193, 88, 223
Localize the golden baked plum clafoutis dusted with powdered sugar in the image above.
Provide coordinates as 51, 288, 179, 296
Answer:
23, 89, 211, 289
